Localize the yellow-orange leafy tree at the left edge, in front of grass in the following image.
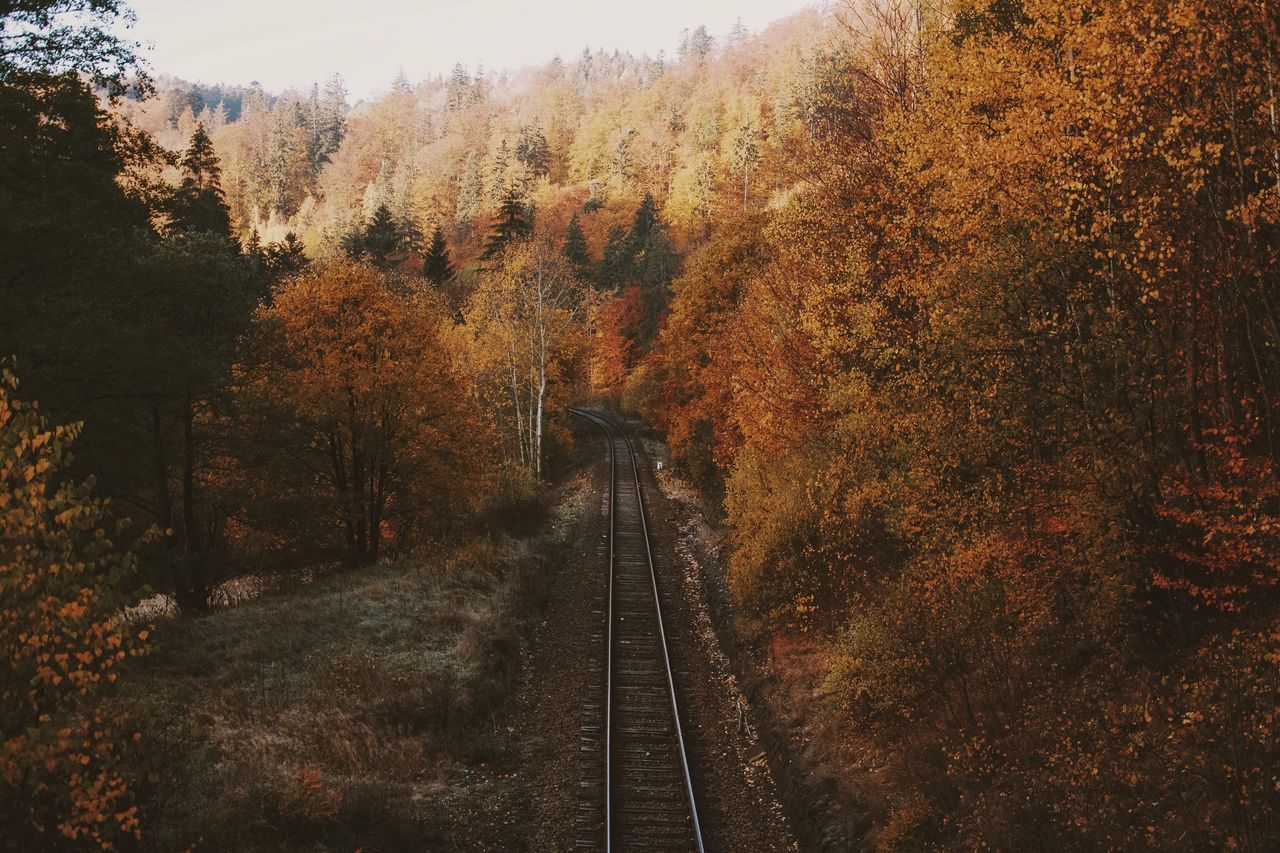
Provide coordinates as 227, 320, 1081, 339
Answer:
0, 364, 147, 849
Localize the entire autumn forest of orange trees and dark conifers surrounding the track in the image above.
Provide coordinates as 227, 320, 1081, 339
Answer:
0, 0, 1280, 850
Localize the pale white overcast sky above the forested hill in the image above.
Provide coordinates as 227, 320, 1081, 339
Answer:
128, 0, 814, 99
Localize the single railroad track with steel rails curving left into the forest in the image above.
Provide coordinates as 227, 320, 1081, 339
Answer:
570, 409, 704, 853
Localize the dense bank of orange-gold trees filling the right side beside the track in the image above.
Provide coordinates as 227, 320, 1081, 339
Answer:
641, 0, 1280, 849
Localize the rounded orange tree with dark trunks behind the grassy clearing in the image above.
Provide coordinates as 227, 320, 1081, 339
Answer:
239, 260, 484, 565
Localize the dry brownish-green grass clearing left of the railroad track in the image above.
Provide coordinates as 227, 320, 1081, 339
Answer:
113, 540, 541, 850
